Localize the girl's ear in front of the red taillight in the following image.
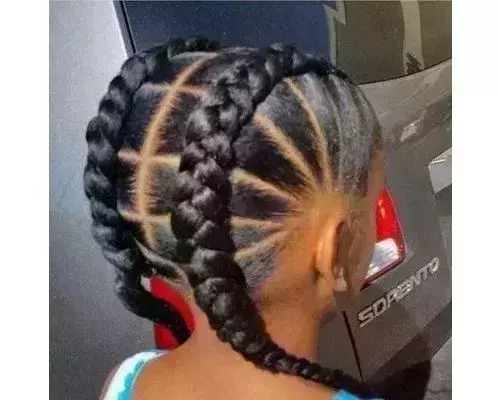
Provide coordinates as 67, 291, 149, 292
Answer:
315, 218, 348, 293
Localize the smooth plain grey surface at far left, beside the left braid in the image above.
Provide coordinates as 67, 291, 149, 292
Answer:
49, 1, 153, 400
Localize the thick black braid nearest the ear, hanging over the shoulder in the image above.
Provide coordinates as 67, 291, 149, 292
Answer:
171, 46, 371, 395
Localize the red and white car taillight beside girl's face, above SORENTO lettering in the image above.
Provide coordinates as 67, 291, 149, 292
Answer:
365, 189, 405, 284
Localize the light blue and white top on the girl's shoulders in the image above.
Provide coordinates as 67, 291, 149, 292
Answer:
103, 350, 380, 400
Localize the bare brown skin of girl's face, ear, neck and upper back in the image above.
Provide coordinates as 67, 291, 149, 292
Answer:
102, 152, 384, 400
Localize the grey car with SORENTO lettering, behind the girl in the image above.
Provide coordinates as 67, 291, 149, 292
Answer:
50, 1, 452, 398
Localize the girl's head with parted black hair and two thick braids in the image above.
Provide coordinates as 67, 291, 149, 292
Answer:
85, 39, 383, 394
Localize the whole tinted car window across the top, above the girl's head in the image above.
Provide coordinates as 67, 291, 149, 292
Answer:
120, 1, 451, 83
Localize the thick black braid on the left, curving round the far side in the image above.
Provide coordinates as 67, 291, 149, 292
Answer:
84, 38, 218, 342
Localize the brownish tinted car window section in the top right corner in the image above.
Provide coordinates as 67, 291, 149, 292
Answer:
325, 1, 451, 83
